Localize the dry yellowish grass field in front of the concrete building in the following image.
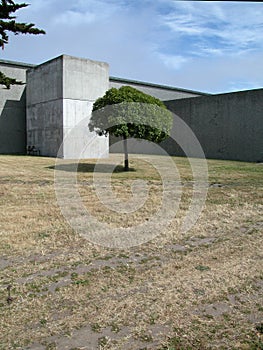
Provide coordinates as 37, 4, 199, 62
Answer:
0, 156, 263, 350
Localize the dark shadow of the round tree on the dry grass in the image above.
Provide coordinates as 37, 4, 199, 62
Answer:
47, 163, 136, 173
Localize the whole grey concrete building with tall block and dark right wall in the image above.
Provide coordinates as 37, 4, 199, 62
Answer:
0, 55, 263, 162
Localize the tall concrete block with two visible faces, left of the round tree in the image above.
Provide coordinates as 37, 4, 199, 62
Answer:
27, 55, 109, 159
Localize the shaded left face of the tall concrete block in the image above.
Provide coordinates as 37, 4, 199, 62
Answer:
26, 57, 63, 157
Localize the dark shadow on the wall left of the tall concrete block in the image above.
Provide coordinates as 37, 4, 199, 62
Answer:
0, 91, 26, 154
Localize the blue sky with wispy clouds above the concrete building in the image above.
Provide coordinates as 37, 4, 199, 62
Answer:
0, 0, 263, 93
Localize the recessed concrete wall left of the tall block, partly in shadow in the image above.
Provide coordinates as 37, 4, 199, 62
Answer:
0, 61, 31, 154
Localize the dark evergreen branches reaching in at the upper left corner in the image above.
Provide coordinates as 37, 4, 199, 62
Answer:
0, 0, 45, 89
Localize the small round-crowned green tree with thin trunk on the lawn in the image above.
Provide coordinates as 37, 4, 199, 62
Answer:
89, 86, 173, 171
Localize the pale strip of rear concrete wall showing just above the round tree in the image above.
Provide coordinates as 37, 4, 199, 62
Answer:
110, 77, 208, 101
